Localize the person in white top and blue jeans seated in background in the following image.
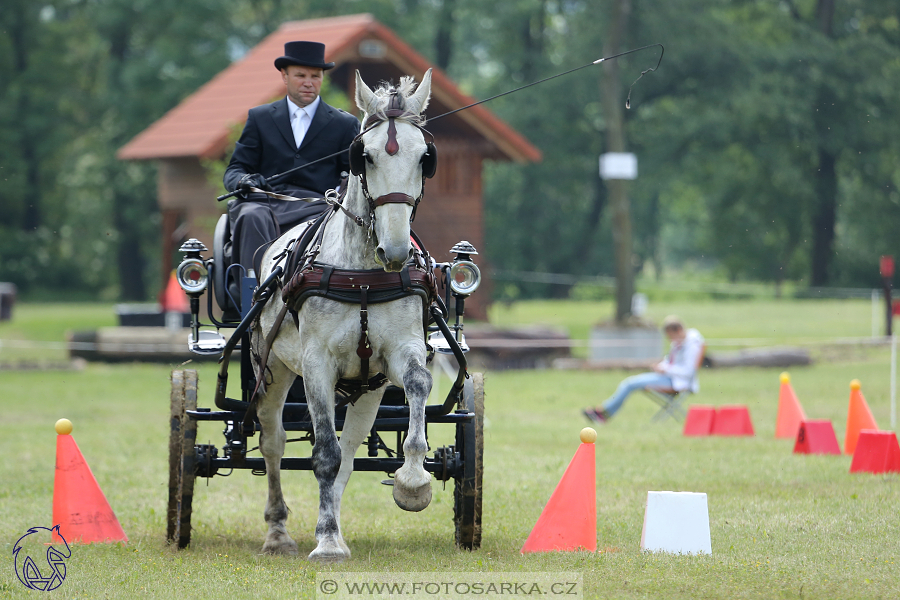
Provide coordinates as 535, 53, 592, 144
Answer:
582, 316, 704, 423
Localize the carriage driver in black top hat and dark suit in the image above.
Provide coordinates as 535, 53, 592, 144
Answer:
223, 41, 359, 274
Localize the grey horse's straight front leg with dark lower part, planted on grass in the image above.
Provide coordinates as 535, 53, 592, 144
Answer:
303, 364, 350, 562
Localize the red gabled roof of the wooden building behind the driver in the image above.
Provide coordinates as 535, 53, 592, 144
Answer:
117, 14, 541, 161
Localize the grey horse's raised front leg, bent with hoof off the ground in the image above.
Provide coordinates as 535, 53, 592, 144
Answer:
391, 356, 432, 511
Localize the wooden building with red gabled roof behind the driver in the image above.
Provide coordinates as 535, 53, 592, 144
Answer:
117, 14, 541, 317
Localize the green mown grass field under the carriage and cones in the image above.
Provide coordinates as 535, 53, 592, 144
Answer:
0, 303, 900, 598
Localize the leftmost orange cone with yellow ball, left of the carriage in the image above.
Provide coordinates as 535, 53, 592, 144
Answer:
53, 419, 128, 543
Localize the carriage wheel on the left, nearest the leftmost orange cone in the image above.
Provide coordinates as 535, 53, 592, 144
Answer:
166, 369, 197, 549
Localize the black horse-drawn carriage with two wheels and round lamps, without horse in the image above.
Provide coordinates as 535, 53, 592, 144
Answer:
167, 229, 484, 550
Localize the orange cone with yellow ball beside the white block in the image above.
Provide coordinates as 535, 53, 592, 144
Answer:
521, 427, 597, 554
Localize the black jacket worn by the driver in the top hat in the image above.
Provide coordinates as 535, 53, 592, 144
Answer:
224, 98, 359, 197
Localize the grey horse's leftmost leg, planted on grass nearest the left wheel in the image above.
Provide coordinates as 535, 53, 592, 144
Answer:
257, 354, 297, 554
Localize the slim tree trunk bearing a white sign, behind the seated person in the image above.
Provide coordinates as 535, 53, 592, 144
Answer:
600, 0, 634, 324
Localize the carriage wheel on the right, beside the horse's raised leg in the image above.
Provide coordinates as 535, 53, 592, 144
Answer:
453, 373, 484, 550
